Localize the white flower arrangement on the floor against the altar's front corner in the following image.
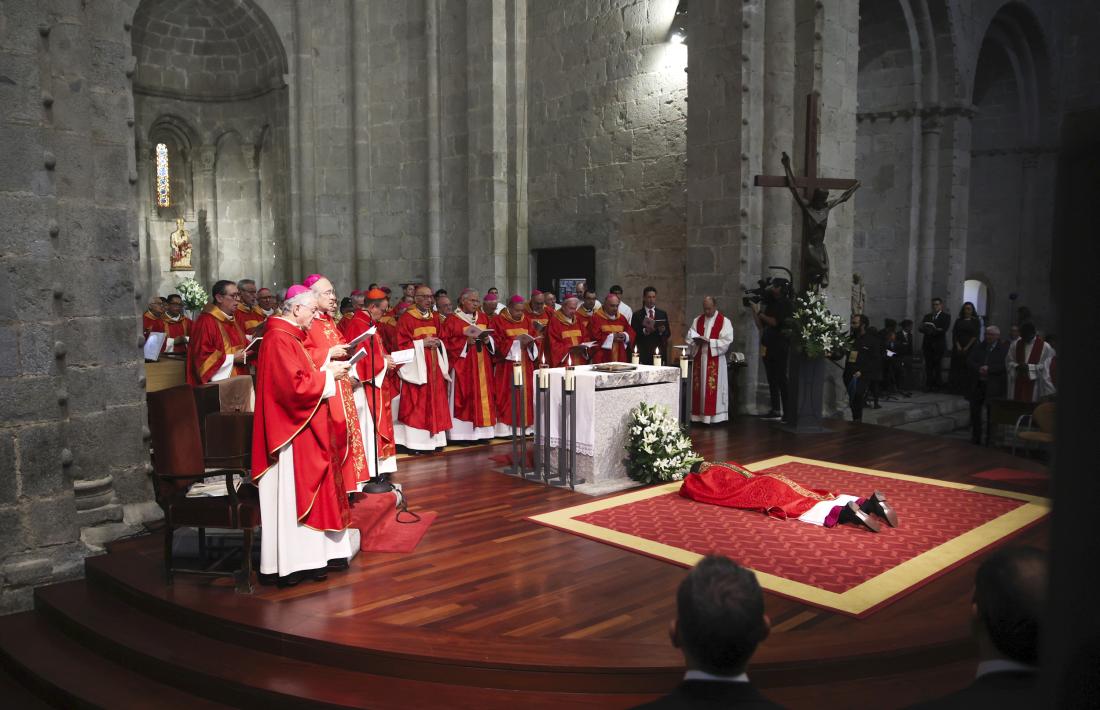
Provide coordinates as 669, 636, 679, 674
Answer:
626, 402, 703, 483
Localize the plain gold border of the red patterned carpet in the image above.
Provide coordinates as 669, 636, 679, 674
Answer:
531, 456, 1051, 615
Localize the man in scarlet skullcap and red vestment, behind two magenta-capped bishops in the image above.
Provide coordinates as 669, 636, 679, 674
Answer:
344, 288, 397, 479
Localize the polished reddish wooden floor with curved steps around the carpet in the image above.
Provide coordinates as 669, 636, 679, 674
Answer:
0, 419, 1048, 708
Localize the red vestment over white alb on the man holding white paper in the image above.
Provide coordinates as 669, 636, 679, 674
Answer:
394, 307, 451, 451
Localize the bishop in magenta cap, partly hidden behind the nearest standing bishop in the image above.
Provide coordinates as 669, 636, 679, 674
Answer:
301, 274, 371, 493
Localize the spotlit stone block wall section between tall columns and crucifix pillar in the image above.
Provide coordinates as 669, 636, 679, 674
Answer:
528, 0, 699, 335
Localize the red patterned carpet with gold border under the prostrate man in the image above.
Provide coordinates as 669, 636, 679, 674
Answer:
530, 456, 1049, 616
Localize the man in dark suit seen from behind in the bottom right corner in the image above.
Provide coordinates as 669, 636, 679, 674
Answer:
915, 547, 1047, 710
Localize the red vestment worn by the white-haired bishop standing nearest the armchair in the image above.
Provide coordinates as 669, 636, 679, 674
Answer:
252, 318, 350, 531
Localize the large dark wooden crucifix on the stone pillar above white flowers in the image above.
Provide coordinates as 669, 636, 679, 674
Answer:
752, 91, 859, 291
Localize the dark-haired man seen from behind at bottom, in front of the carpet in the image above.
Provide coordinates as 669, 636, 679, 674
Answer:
639, 555, 781, 709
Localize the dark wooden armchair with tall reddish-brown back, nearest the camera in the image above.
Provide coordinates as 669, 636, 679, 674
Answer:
146, 385, 260, 592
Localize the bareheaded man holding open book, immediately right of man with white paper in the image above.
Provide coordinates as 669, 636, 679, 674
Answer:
440, 288, 497, 441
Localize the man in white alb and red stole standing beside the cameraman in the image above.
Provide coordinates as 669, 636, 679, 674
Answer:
688, 296, 734, 424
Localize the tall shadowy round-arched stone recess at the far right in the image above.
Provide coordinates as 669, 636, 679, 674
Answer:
967, 1, 1057, 330
